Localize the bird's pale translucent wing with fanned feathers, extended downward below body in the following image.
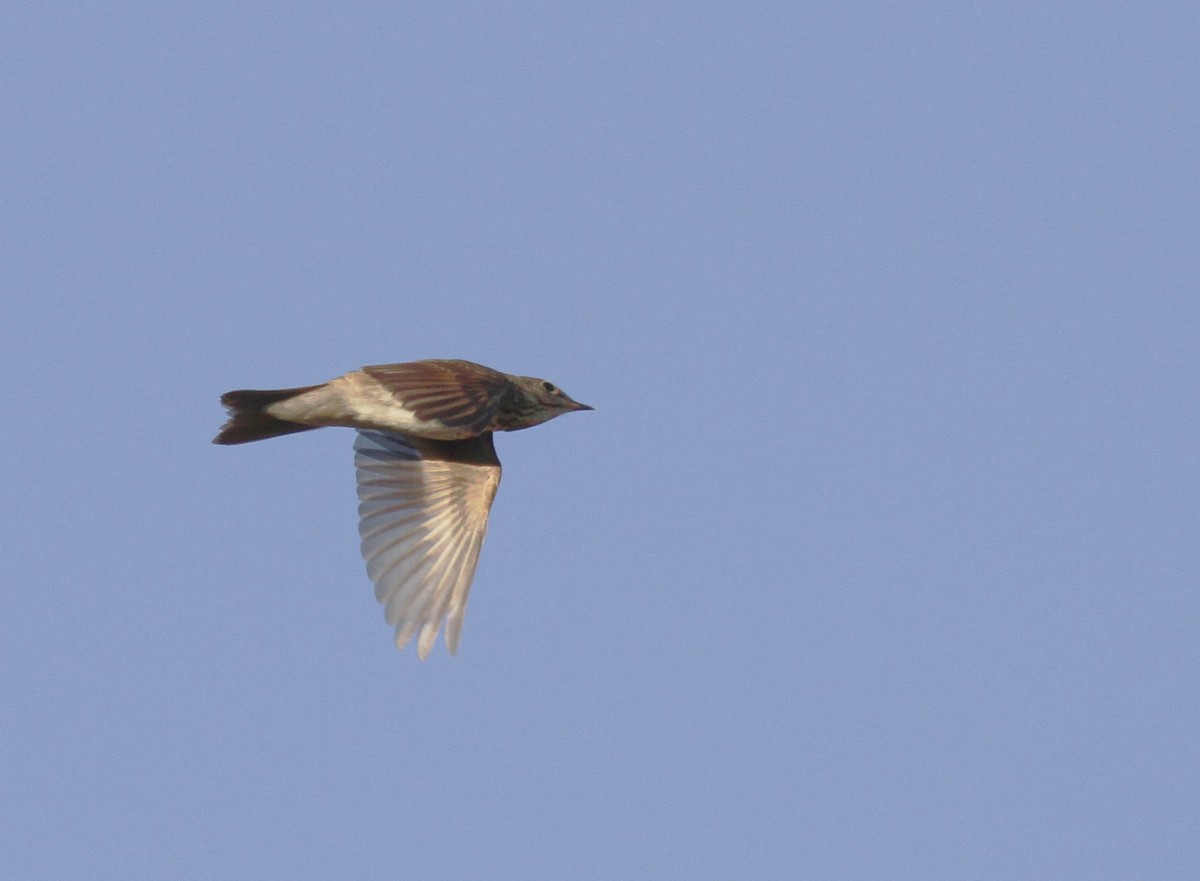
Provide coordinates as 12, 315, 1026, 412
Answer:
354, 431, 500, 660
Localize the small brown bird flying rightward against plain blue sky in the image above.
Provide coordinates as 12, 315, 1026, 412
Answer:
212, 359, 594, 660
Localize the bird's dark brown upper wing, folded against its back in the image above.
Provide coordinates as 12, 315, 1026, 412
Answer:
362, 360, 511, 436
